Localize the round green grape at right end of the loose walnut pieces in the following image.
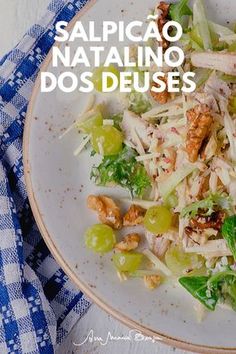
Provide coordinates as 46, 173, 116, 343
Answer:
144, 205, 172, 234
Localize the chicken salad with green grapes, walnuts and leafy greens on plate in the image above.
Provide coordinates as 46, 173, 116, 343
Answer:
62, 0, 236, 311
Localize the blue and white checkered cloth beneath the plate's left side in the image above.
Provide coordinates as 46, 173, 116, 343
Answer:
0, 0, 89, 354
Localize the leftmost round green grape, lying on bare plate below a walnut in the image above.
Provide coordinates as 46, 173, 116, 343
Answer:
85, 224, 116, 253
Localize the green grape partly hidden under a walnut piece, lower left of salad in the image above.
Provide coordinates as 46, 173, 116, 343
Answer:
112, 252, 143, 272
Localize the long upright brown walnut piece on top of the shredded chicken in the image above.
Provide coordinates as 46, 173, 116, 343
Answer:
186, 105, 213, 162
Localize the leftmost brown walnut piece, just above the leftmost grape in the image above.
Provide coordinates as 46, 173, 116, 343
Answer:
87, 195, 122, 229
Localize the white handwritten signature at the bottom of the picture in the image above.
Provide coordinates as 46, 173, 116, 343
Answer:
73, 329, 161, 347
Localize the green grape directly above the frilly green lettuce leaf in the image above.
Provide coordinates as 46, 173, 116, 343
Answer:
91, 125, 123, 156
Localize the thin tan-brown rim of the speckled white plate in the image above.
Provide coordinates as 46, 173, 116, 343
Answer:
23, 0, 236, 354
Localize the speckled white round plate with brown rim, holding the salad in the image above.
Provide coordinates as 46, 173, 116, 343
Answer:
24, 0, 236, 353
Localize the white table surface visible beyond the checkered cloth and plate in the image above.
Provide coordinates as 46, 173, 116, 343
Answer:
0, 0, 191, 354
